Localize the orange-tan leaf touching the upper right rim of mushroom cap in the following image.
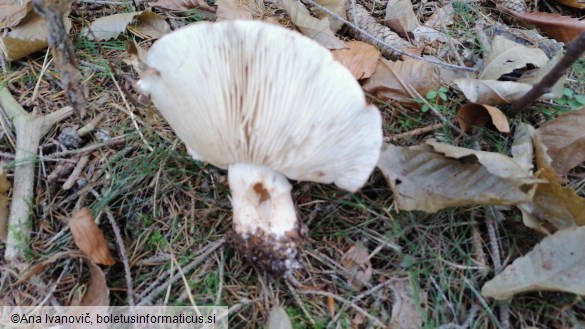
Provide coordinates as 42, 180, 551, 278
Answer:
331, 41, 380, 80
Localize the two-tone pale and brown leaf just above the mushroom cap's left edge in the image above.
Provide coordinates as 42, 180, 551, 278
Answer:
83, 11, 171, 41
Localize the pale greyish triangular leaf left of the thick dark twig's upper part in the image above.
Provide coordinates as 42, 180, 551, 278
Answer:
479, 35, 548, 80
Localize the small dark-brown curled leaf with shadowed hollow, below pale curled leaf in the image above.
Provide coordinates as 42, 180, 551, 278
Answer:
457, 103, 510, 133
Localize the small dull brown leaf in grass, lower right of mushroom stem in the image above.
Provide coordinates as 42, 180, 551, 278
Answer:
341, 242, 373, 291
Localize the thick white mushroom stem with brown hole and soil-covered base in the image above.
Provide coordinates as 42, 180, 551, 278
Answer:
228, 163, 301, 274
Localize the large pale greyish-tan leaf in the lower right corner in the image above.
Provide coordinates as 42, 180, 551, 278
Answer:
481, 227, 585, 299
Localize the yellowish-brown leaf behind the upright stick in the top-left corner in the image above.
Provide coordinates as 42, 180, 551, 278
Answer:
0, 4, 71, 61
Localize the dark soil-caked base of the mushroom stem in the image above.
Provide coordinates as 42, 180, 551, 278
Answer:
227, 229, 304, 276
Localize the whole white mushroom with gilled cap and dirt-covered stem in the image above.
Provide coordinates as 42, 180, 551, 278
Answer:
138, 21, 382, 274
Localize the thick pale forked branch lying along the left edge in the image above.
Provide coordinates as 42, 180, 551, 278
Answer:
0, 87, 73, 269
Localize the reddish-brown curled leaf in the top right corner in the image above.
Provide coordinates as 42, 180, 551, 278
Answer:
509, 11, 585, 43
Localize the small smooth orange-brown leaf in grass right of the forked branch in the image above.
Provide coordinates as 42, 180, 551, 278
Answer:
69, 207, 116, 265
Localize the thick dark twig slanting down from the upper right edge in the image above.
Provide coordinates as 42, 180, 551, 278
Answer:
506, 32, 585, 116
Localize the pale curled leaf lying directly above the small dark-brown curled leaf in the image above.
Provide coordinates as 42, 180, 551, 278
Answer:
453, 78, 556, 106
